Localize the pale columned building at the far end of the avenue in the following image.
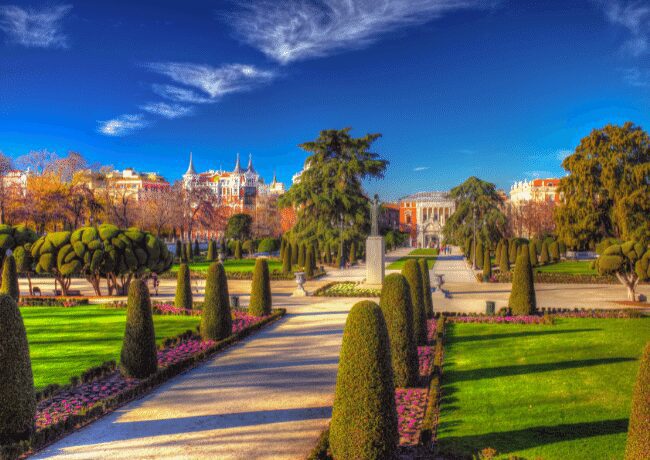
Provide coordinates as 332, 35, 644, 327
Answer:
399, 192, 456, 248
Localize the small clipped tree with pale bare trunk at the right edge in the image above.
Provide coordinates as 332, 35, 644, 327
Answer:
594, 239, 650, 301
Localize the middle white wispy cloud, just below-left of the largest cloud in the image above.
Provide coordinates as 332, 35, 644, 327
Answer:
147, 62, 275, 102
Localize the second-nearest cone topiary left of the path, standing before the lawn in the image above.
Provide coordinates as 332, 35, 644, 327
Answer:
120, 279, 158, 378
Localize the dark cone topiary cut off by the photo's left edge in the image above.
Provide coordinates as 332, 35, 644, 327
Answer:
0, 294, 36, 444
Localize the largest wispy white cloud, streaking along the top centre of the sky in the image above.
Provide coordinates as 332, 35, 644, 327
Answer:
225, 0, 488, 64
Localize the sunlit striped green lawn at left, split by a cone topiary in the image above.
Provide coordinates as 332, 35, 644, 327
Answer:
20, 305, 200, 389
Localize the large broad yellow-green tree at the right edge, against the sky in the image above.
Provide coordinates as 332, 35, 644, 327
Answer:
556, 122, 650, 249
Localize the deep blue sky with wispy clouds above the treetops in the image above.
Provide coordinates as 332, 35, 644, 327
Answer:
0, 0, 650, 199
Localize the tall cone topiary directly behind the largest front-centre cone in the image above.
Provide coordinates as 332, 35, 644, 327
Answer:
379, 273, 419, 388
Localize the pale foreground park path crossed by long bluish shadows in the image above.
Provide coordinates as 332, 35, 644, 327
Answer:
35, 296, 359, 459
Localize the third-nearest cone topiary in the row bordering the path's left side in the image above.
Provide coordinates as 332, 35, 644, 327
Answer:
200, 262, 232, 340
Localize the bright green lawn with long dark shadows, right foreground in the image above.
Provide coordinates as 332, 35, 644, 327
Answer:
438, 318, 650, 460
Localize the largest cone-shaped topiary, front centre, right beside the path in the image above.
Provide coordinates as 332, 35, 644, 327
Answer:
329, 300, 399, 460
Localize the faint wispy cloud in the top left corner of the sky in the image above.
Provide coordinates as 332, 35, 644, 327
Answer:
0, 5, 72, 48
